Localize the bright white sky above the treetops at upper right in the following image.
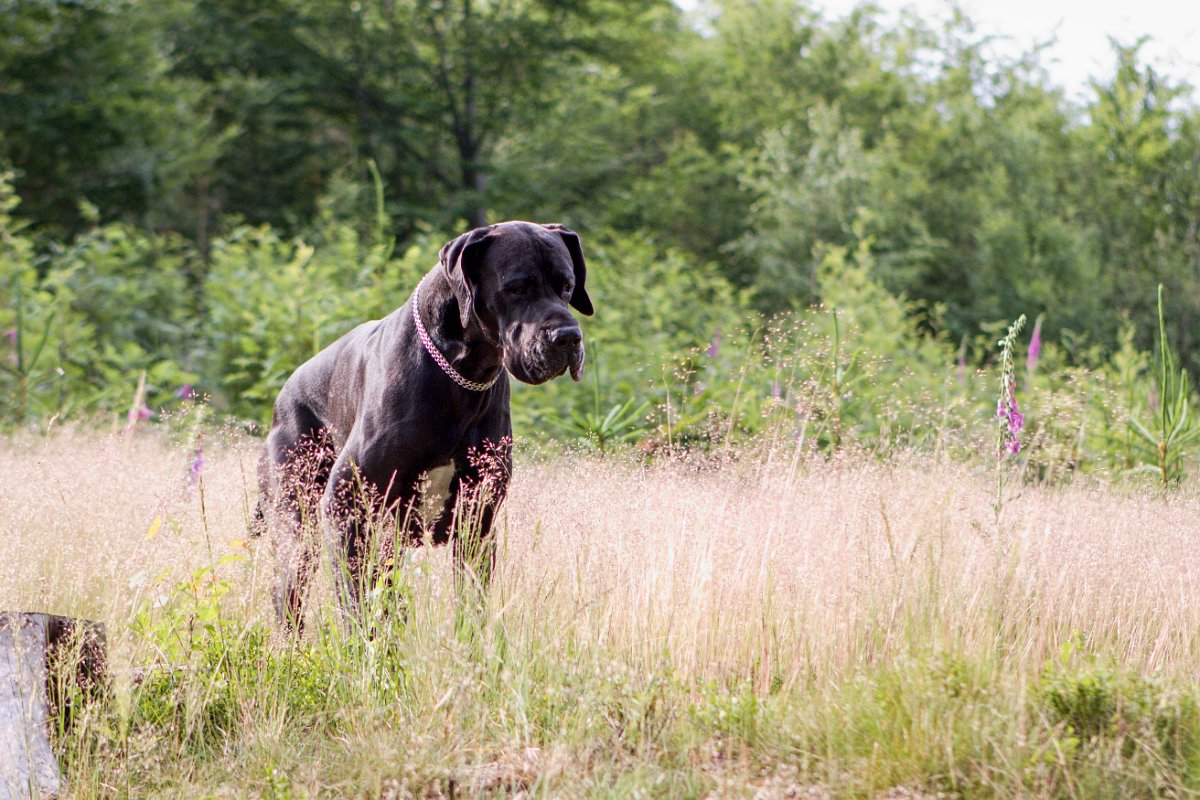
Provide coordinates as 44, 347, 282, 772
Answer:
814, 0, 1200, 97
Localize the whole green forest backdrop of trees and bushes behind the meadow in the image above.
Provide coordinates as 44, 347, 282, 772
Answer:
0, 0, 1200, 480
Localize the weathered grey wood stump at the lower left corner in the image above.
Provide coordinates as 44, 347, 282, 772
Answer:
0, 612, 104, 800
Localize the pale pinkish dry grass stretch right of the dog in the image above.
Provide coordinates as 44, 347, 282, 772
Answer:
502, 443, 1200, 681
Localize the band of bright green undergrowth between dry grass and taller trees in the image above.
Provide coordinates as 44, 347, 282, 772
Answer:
7, 169, 1195, 481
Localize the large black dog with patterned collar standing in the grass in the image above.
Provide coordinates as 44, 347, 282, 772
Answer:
253, 222, 593, 627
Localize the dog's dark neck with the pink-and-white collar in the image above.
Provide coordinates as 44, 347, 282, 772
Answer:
416, 269, 504, 383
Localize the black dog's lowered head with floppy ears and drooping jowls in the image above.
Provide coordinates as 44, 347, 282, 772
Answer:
440, 222, 593, 384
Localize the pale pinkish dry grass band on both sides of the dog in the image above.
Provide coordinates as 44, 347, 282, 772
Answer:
0, 431, 1200, 789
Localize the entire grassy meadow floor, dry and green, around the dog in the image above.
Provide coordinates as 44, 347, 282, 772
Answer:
0, 427, 1200, 799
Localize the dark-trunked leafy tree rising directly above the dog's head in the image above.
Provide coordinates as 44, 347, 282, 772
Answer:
277, 0, 670, 231
